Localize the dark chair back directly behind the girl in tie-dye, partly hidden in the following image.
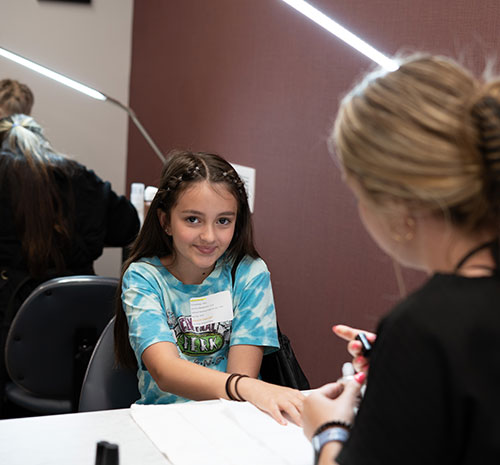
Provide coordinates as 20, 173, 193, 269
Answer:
78, 317, 140, 412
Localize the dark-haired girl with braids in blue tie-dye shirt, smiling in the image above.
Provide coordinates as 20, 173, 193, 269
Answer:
115, 151, 304, 424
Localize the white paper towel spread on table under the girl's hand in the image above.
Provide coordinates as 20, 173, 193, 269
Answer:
130, 400, 313, 465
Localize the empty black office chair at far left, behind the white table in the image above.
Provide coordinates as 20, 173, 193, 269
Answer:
5, 276, 118, 415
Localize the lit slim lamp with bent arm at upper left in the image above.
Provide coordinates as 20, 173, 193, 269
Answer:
0, 47, 165, 163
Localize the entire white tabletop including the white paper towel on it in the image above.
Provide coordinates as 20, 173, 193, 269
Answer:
0, 400, 313, 465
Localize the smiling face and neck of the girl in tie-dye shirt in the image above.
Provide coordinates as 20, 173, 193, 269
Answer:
160, 181, 238, 284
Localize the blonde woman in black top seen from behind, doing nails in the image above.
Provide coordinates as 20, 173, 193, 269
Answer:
303, 55, 500, 465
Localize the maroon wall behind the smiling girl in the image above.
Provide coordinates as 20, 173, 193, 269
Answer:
127, 0, 500, 386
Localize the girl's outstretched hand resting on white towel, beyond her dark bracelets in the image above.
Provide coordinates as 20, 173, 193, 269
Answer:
238, 378, 305, 426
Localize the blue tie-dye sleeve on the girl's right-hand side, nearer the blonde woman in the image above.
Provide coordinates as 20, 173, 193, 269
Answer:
230, 260, 279, 353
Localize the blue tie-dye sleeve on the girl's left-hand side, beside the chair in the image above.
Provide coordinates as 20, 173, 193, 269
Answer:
121, 263, 175, 363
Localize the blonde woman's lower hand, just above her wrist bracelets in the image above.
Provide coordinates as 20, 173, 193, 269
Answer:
302, 373, 366, 440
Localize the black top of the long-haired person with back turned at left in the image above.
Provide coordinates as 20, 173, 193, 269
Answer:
0, 159, 140, 418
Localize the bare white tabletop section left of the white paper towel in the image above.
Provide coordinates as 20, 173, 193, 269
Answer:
0, 409, 171, 465
